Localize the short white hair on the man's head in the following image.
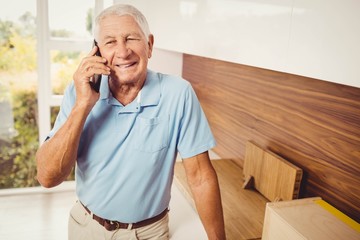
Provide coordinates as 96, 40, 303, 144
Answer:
94, 4, 151, 41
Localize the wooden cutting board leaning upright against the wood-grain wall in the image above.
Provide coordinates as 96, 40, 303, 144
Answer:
243, 141, 302, 201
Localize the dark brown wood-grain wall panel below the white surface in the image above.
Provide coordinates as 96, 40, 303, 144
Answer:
183, 54, 360, 221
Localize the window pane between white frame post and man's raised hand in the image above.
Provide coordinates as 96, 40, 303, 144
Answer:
48, 0, 94, 95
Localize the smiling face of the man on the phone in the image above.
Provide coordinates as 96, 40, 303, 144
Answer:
98, 15, 153, 86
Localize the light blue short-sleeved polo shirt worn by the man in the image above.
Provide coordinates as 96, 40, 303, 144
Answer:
49, 70, 215, 223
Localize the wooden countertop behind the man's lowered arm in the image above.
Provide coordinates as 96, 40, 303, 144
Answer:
174, 159, 268, 240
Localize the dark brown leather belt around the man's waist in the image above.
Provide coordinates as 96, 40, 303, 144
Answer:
81, 203, 169, 231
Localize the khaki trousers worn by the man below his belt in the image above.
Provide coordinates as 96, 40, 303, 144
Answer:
68, 201, 169, 240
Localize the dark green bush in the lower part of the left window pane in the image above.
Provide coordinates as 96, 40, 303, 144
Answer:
0, 90, 39, 188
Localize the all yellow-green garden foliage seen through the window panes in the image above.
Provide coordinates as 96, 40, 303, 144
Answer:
0, 11, 90, 189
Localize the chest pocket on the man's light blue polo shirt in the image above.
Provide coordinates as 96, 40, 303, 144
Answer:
134, 117, 169, 152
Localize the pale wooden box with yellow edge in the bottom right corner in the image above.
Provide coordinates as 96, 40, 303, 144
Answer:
262, 198, 360, 240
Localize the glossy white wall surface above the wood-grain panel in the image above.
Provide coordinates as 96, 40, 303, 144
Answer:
115, 0, 360, 87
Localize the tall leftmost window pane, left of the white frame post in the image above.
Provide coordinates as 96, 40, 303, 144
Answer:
0, 0, 38, 188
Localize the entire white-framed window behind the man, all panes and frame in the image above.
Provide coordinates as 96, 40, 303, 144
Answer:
0, 0, 112, 189
